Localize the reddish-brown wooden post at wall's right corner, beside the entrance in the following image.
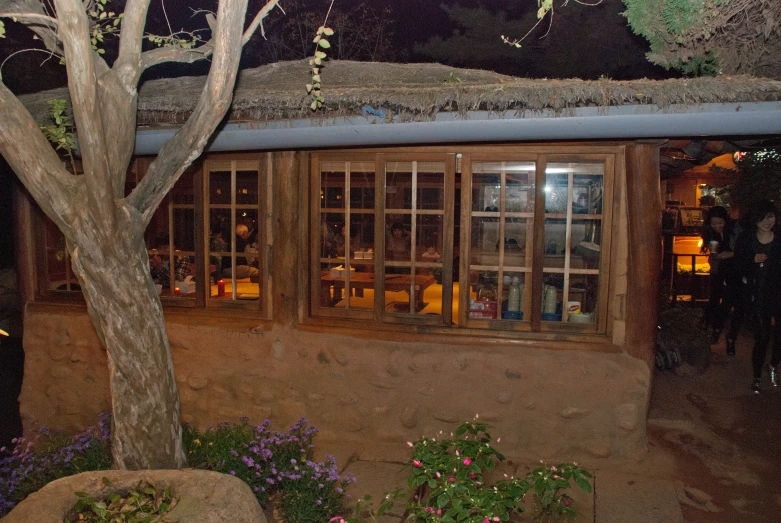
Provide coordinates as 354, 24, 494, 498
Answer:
626, 142, 662, 367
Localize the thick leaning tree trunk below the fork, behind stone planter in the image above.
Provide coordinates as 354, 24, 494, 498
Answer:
68, 208, 186, 469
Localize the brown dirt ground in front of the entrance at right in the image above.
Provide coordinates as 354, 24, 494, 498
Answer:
640, 332, 781, 523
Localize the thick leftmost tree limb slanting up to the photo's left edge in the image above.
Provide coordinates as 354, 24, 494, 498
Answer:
0, 82, 84, 232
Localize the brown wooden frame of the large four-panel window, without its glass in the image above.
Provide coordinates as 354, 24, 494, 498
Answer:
309, 144, 624, 341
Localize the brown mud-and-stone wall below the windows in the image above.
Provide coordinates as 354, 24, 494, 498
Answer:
21, 305, 650, 459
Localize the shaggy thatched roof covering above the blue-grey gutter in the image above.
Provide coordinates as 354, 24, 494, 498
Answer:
22, 60, 781, 126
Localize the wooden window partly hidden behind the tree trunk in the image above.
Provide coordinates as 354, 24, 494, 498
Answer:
39, 155, 270, 311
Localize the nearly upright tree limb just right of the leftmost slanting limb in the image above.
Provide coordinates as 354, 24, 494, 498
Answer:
54, 0, 116, 231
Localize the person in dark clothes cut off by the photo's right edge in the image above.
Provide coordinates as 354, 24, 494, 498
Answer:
735, 200, 781, 394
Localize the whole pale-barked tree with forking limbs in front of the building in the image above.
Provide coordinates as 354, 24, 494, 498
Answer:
0, 0, 278, 469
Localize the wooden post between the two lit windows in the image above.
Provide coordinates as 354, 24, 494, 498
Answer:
271, 152, 304, 325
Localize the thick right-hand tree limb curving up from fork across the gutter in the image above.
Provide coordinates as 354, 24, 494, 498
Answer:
128, 0, 251, 226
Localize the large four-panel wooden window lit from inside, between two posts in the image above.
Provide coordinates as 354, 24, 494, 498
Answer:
311, 148, 614, 333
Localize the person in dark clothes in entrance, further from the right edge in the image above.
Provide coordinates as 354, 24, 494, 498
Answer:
702, 206, 742, 355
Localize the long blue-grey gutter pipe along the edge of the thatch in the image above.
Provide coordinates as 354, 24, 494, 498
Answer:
135, 102, 781, 155
